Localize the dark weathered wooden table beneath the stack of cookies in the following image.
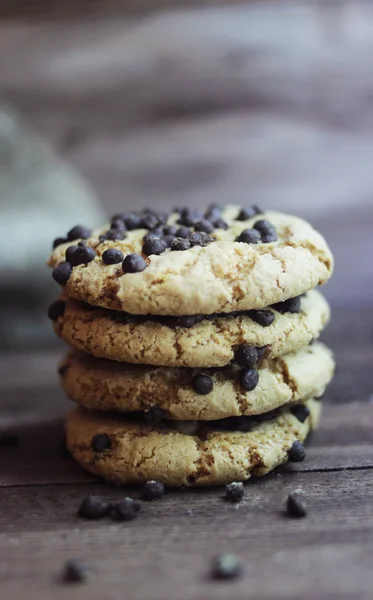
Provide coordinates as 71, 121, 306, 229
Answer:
0, 308, 373, 600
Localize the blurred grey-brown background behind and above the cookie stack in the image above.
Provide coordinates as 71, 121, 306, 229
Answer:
0, 0, 373, 350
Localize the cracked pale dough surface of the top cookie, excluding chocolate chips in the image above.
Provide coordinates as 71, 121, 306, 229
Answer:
49, 206, 333, 315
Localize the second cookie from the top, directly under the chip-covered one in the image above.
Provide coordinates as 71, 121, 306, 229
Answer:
50, 290, 330, 367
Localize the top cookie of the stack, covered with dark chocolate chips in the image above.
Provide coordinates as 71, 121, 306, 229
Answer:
49, 206, 333, 316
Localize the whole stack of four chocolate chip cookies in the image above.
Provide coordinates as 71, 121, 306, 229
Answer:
49, 205, 334, 486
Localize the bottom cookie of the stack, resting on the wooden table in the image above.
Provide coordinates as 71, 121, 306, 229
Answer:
66, 399, 321, 486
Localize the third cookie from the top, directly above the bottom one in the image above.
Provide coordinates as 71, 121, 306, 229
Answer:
61, 343, 334, 420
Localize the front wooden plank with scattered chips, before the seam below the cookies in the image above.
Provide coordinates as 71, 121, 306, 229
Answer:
0, 471, 373, 600
